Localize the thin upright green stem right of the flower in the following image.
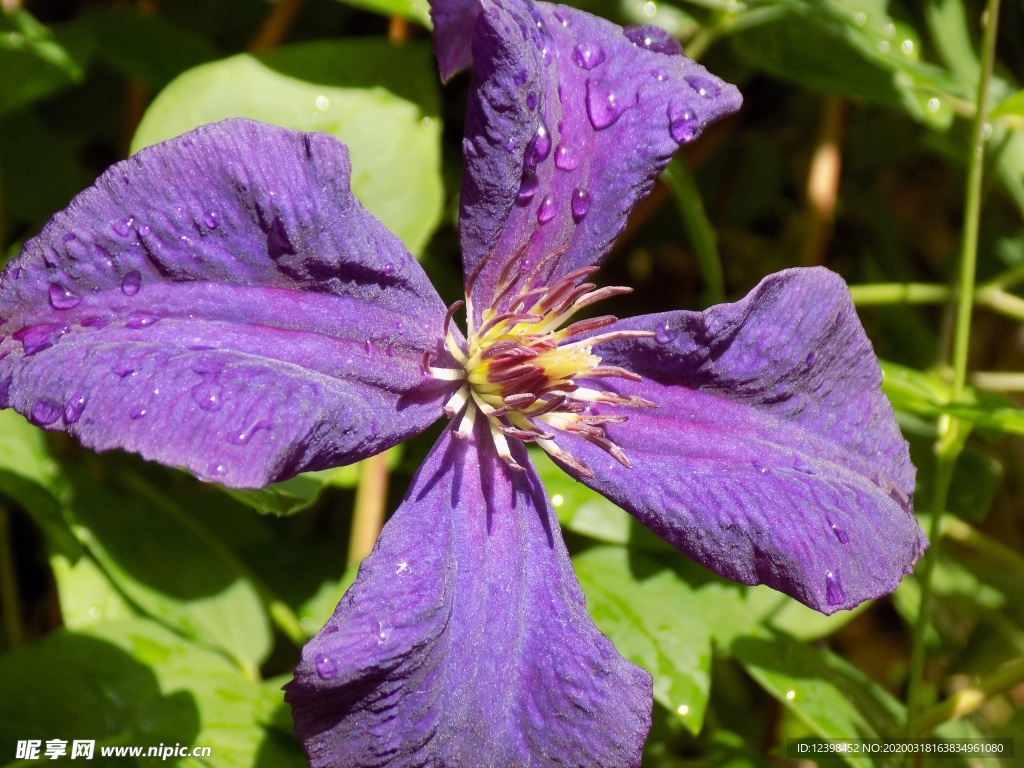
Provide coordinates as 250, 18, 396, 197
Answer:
906, 0, 999, 737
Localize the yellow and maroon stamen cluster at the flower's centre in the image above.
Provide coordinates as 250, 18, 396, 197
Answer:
425, 259, 653, 476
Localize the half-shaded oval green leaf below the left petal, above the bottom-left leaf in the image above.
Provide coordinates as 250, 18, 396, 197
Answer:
65, 475, 271, 670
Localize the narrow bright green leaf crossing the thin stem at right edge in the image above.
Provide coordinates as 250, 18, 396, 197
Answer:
882, 361, 1024, 434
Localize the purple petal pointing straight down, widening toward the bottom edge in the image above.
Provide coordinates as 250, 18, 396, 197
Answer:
286, 430, 651, 768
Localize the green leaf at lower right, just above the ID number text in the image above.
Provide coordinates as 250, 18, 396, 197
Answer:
732, 635, 905, 768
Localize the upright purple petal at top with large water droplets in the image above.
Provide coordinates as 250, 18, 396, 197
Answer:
460, 0, 740, 323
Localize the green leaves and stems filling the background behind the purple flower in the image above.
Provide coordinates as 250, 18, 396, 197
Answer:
0, 0, 1024, 768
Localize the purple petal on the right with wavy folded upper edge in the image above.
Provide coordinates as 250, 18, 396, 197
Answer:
564, 268, 927, 613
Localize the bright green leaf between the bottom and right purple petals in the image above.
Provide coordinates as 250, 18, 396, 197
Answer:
572, 547, 711, 733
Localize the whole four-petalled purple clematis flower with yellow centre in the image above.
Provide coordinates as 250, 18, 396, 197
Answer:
0, 0, 927, 768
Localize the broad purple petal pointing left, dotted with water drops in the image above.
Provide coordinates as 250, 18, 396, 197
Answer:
0, 120, 454, 485
